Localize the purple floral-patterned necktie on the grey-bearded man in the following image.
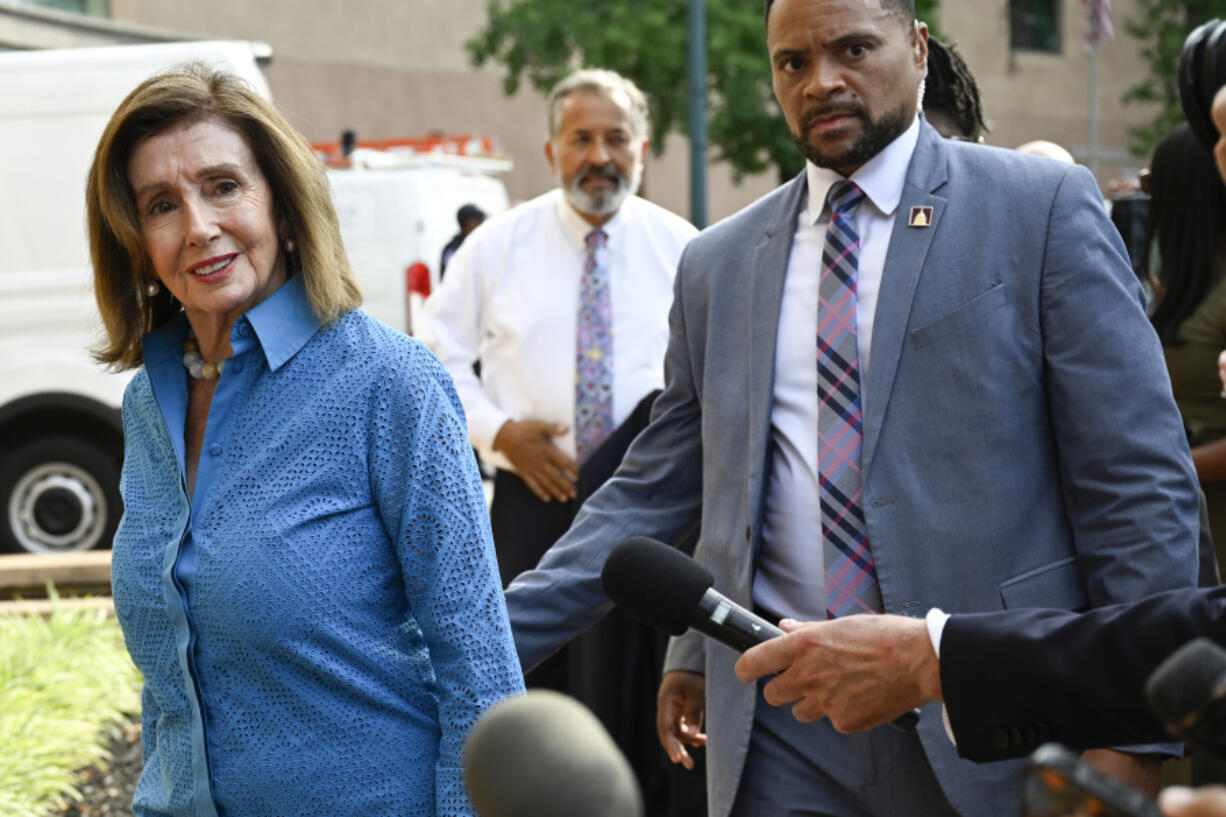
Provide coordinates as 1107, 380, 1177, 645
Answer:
575, 229, 613, 464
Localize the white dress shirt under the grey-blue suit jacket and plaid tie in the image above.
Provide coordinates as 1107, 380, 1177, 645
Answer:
754, 119, 920, 621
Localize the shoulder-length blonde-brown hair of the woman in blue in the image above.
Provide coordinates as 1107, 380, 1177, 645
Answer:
86, 63, 362, 369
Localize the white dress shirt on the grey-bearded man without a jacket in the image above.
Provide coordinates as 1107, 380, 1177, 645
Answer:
419, 189, 698, 469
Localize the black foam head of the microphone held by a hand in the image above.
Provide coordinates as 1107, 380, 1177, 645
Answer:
601, 536, 715, 635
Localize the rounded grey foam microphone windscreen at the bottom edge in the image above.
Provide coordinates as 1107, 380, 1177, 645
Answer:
463, 689, 642, 817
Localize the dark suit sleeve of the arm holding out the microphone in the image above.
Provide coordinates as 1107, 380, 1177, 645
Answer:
940, 588, 1226, 761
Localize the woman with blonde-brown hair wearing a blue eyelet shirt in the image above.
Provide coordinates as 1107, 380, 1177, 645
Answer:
87, 64, 522, 817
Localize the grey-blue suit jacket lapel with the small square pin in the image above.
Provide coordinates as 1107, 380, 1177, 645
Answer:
861, 124, 948, 475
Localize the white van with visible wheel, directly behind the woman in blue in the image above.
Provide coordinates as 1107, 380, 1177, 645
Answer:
0, 42, 270, 553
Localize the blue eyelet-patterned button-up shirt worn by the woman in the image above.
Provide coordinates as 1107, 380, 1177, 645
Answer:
112, 278, 524, 817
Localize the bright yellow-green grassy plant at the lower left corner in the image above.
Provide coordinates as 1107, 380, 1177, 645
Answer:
0, 594, 141, 817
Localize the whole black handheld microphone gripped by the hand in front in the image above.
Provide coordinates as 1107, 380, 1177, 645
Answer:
601, 536, 920, 731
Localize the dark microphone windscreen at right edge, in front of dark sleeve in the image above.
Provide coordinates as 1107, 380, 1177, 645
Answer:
1145, 638, 1226, 737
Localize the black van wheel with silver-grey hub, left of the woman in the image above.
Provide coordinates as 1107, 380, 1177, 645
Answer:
0, 437, 123, 553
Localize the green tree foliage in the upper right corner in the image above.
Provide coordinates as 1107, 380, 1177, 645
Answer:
1124, 0, 1226, 156
